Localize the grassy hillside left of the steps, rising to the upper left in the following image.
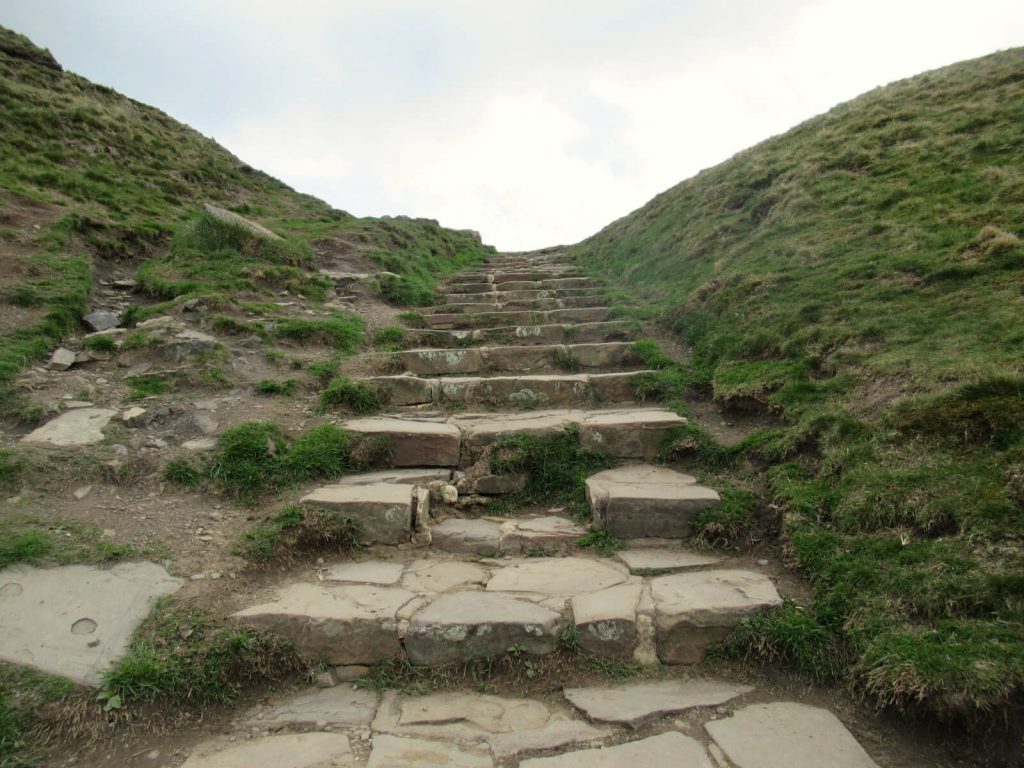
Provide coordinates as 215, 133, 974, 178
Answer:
0, 28, 492, 410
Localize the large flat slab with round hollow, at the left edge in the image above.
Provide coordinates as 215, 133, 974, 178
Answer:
0, 562, 182, 686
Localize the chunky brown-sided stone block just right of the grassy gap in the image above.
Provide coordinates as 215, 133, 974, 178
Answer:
587, 465, 721, 539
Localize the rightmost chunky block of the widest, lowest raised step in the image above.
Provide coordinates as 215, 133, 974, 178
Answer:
650, 570, 782, 664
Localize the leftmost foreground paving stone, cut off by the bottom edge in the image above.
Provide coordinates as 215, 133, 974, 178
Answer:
181, 733, 355, 768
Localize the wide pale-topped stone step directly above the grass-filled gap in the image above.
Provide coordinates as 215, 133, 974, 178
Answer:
344, 408, 686, 467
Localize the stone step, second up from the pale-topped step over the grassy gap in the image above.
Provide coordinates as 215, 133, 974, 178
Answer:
376, 341, 642, 376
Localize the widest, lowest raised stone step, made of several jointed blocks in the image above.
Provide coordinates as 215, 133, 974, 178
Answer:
234, 556, 781, 665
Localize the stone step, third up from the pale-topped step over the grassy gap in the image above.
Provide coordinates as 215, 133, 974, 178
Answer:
409, 321, 637, 348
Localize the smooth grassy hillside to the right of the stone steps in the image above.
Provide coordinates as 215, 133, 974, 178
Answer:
573, 49, 1024, 717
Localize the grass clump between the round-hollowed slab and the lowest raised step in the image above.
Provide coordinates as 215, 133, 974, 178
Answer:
101, 598, 305, 708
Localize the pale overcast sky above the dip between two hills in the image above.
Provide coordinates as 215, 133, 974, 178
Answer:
6, 0, 1024, 249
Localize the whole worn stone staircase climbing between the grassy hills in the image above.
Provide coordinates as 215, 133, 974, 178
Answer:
236, 254, 780, 667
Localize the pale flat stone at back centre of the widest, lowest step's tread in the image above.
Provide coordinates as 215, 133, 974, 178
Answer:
487, 557, 628, 597
